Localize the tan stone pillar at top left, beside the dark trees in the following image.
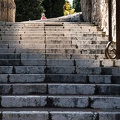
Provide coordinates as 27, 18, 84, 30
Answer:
0, 0, 16, 22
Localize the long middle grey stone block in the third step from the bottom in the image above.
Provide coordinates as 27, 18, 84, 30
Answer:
48, 84, 95, 95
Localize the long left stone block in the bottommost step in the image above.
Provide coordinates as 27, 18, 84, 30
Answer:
2, 111, 49, 120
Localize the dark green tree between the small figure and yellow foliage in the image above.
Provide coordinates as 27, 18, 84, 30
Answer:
42, 0, 65, 18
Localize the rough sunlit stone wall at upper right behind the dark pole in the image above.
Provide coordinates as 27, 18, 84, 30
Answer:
81, 0, 116, 40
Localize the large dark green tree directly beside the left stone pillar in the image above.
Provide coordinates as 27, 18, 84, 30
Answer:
15, 0, 44, 21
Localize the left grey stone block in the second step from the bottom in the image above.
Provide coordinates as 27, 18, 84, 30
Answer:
1, 96, 47, 108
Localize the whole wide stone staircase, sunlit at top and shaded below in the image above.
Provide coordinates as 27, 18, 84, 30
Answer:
0, 21, 120, 120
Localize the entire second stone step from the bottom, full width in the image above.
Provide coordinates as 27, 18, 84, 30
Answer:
1, 95, 120, 109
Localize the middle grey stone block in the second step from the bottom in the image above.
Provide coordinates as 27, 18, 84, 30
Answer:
48, 96, 89, 108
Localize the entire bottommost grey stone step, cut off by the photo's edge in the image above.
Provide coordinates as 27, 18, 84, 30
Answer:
1, 108, 120, 120
